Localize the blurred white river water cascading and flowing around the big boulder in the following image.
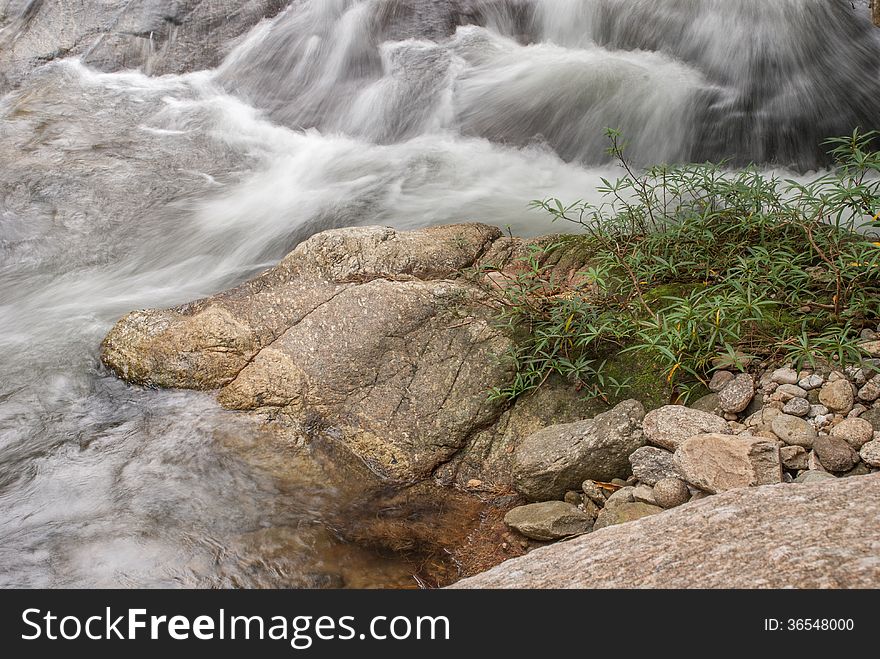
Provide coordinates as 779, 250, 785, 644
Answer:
0, 0, 880, 587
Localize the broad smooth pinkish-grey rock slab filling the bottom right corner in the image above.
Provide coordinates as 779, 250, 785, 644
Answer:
455, 475, 880, 589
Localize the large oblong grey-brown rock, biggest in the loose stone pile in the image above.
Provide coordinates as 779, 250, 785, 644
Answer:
513, 401, 645, 501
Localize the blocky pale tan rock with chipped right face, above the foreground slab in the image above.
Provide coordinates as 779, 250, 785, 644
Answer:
675, 434, 782, 493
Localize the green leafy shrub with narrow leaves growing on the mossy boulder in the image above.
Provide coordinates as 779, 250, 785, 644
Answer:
482, 131, 880, 398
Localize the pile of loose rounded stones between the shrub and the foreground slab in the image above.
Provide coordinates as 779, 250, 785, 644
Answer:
505, 360, 880, 542
